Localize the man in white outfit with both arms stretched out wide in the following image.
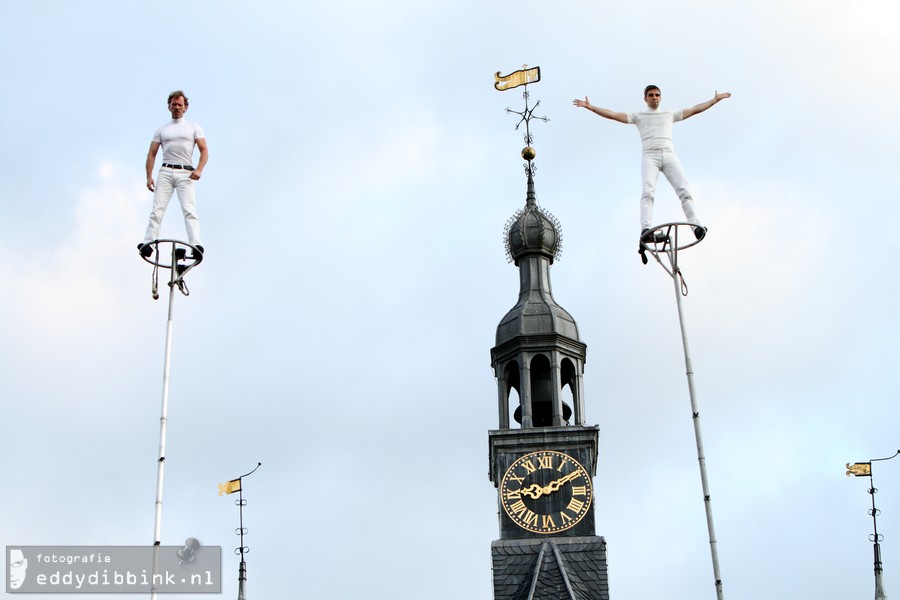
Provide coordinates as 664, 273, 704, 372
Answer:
573, 85, 731, 253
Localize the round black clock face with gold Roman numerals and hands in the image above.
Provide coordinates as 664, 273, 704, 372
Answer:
500, 450, 593, 533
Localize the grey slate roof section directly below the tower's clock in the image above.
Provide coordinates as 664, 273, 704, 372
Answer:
491, 536, 609, 600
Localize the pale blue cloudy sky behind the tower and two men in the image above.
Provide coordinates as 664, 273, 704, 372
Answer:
0, 0, 900, 600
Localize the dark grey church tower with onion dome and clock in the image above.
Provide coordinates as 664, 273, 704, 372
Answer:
488, 170, 609, 600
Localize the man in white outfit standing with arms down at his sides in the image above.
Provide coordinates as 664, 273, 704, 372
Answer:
138, 90, 209, 257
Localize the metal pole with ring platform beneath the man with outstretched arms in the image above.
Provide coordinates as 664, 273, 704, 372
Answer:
644, 223, 725, 600
